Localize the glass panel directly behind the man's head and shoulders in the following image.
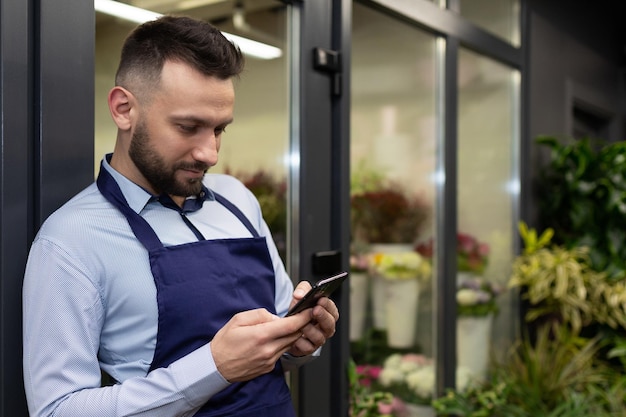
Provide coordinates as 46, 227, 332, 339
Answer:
94, 0, 289, 259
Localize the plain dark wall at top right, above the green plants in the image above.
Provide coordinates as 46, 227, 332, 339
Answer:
524, 0, 626, 222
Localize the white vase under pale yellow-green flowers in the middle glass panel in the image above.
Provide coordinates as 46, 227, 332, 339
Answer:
385, 277, 419, 348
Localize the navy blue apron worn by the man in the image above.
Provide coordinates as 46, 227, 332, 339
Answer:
97, 162, 295, 417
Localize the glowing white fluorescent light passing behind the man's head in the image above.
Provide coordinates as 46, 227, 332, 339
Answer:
94, 0, 283, 59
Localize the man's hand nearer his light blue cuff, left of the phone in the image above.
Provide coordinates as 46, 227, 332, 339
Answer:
211, 307, 310, 382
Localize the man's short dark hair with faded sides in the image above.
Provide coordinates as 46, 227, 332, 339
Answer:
115, 16, 244, 95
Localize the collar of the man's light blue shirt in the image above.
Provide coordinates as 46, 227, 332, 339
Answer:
102, 154, 215, 213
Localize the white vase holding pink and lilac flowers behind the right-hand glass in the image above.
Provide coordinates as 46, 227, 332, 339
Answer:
456, 314, 493, 379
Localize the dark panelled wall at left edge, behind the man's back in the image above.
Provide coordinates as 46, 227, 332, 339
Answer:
0, 0, 94, 417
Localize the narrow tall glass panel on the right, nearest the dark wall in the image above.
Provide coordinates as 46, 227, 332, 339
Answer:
457, 49, 519, 382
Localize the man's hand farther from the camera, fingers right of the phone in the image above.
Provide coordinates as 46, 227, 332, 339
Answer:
288, 281, 339, 356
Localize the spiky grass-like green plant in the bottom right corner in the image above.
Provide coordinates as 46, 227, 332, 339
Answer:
433, 324, 626, 417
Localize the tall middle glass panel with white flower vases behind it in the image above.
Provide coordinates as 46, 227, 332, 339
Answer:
350, 4, 436, 412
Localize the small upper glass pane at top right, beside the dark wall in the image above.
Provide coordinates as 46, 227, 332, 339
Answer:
459, 0, 520, 46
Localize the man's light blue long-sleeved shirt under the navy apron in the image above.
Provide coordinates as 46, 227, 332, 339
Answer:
23, 160, 309, 417
